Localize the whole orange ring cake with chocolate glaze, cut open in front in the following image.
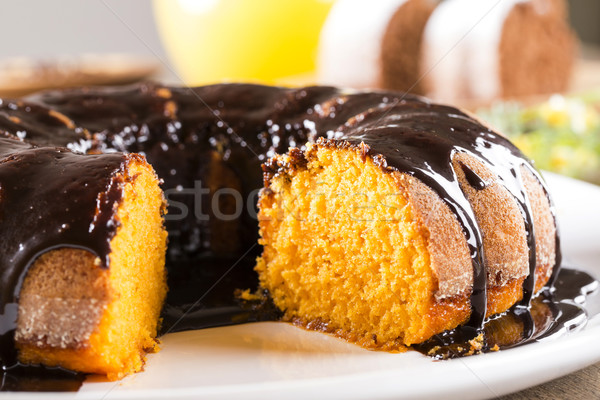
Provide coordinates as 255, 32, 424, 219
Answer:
0, 83, 560, 377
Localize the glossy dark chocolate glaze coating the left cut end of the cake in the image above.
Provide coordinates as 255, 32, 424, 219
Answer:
0, 138, 127, 368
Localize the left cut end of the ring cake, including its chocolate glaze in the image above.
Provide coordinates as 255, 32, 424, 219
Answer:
0, 134, 167, 379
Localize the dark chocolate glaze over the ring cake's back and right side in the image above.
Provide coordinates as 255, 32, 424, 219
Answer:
0, 83, 576, 390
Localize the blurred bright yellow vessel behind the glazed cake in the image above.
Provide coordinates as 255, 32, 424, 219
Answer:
154, 0, 334, 85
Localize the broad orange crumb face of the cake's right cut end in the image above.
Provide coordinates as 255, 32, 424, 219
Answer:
256, 145, 469, 350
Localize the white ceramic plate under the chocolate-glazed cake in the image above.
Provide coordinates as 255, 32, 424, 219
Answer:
5, 174, 600, 400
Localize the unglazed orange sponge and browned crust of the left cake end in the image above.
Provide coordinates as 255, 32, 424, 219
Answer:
15, 158, 167, 379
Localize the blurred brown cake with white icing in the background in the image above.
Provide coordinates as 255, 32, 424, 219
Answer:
318, 0, 575, 103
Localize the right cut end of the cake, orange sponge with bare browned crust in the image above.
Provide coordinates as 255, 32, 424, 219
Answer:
256, 130, 555, 350
